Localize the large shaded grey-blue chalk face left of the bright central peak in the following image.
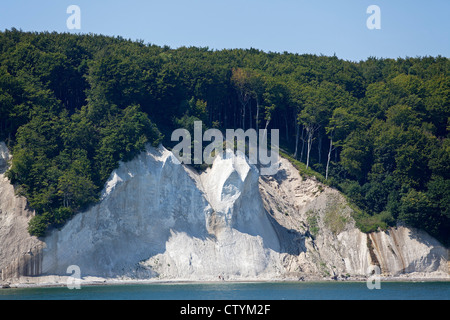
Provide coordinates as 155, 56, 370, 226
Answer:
42, 148, 211, 277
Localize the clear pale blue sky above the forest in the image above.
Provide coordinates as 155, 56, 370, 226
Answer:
0, 0, 450, 61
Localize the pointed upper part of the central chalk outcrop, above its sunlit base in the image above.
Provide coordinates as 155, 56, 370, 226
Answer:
200, 150, 280, 251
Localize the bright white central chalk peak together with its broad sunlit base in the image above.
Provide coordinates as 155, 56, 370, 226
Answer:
142, 152, 286, 280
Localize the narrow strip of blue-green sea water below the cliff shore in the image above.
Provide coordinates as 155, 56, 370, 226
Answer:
0, 281, 450, 300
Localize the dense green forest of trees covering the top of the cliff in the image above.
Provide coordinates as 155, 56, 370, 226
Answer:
0, 29, 450, 245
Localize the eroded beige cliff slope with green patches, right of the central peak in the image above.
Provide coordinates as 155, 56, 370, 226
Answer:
260, 159, 450, 279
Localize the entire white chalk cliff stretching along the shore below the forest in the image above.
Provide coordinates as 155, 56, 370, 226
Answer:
0, 144, 449, 281
